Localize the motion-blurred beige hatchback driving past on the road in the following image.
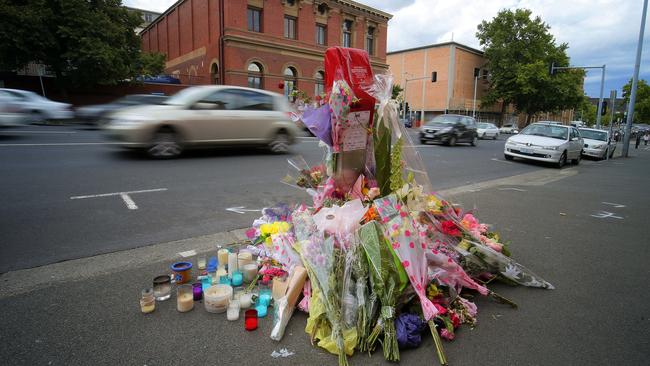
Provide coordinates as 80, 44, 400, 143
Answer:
104, 85, 300, 158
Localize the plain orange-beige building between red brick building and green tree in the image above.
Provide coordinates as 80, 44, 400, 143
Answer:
386, 42, 501, 120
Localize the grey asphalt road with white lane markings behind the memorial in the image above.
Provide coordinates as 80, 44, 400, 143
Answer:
0, 126, 608, 273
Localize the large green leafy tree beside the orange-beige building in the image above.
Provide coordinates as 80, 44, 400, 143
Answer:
476, 9, 584, 125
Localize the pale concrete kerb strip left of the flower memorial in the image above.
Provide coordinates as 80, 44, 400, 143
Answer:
0, 229, 246, 298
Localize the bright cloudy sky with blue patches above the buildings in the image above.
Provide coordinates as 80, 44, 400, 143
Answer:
123, 0, 650, 98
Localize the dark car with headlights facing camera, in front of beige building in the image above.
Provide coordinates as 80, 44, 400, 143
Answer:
420, 114, 478, 146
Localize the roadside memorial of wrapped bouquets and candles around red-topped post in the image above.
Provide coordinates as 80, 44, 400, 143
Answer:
141, 47, 553, 365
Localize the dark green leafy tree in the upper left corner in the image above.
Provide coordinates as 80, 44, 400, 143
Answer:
0, 0, 163, 91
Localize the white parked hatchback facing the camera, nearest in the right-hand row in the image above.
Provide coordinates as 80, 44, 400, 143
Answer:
503, 122, 584, 168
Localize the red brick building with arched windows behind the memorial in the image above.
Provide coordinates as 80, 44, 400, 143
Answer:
140, 0, 391, 94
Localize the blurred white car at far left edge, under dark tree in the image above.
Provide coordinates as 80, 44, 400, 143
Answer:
0, 88, 73, 122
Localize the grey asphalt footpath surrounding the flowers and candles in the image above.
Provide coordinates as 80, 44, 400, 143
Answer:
0, 146, 650, 365
